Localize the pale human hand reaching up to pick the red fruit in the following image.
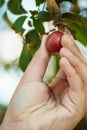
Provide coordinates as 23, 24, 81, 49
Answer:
0, 34, 87, 130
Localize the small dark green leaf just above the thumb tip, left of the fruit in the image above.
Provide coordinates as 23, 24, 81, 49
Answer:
33, 18, 45, 35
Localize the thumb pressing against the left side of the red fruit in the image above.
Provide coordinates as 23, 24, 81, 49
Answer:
21, 35, 50, 81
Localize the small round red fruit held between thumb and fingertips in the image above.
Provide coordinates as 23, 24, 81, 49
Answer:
46, 31, 63, 53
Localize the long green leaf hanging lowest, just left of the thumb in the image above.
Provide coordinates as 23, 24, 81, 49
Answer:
19, 30, 41, 71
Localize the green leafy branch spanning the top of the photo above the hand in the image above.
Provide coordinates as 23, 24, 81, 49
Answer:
0, 0, 87, 71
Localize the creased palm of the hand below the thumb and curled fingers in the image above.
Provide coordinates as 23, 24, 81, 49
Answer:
8, 69, 82, 130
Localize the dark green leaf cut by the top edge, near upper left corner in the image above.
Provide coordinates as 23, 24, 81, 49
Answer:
8, 0, 26, 14
